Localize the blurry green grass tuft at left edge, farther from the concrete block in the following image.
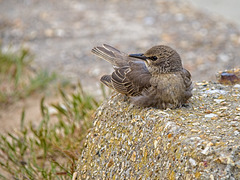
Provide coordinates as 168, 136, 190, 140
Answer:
0, 47, 56, 105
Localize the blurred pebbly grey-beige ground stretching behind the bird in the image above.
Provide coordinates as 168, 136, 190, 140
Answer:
0, 0, 240, 93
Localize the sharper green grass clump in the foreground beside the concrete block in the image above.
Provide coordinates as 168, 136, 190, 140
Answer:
0, 84, 99, 179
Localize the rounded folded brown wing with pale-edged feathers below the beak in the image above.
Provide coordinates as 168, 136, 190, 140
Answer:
111, 61, 151, 96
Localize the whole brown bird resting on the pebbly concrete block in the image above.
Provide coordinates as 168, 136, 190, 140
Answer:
91, 44, 193, 109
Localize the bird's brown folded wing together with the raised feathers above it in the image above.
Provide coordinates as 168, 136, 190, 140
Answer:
92, 44, 151, 96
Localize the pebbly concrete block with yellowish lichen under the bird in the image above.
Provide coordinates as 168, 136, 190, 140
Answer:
77, 82, 240, 179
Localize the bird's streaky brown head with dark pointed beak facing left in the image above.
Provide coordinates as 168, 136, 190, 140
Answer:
129, 45, 182, 73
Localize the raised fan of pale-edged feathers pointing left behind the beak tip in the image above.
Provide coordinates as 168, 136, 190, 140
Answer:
91, 44, 135, 69
